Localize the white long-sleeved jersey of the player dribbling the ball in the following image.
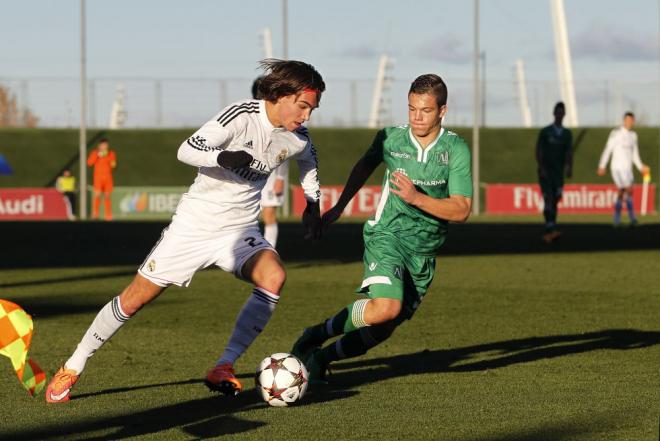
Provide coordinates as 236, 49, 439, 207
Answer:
174, 100, 321, 231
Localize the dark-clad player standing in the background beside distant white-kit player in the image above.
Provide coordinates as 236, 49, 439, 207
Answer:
536, 102, 573, 243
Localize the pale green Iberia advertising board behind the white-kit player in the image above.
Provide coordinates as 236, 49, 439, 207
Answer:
113, 187, 188, 219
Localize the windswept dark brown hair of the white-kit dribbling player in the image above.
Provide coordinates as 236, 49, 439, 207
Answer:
258, 58, 325, 102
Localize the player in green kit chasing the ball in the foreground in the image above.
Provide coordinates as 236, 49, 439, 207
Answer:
291, 74, 472, 381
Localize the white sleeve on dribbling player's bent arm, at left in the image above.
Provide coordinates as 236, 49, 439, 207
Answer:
177, 119, 234, 167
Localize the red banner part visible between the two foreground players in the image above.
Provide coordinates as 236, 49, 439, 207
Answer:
293, 185, 381, 217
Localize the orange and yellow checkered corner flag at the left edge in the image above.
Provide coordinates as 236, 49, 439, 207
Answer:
0, 299, 46, 396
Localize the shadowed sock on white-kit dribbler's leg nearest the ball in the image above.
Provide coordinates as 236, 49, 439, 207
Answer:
216, 288, 280, 365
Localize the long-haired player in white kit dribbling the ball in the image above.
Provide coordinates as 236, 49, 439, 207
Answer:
46, 59, 325, 403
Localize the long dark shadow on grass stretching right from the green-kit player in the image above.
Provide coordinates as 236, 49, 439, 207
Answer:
322, 329, 660, 389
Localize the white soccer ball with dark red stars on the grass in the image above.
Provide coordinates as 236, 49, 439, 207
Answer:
254, 352, 309, 407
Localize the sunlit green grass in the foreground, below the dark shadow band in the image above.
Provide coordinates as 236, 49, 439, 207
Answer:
0, 251, 660, 441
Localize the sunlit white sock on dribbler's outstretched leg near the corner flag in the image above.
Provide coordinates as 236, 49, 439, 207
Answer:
64, 296, 130, 375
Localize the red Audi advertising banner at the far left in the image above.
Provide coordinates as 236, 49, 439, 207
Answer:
0, 188, 68, 220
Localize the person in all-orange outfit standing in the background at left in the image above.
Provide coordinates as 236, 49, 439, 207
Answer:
87, 138, 117, 220
